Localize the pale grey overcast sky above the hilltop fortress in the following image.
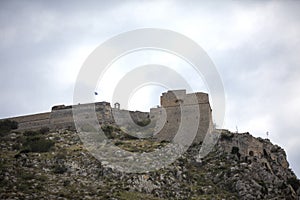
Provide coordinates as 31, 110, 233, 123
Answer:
0, 1, 300, 177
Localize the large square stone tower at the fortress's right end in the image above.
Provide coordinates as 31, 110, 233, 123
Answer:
150, 90, 213, 143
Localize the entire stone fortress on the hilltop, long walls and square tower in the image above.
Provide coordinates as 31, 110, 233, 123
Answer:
2, 90, 213, 143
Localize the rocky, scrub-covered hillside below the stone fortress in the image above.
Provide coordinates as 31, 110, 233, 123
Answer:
0, 127, 300, 199
